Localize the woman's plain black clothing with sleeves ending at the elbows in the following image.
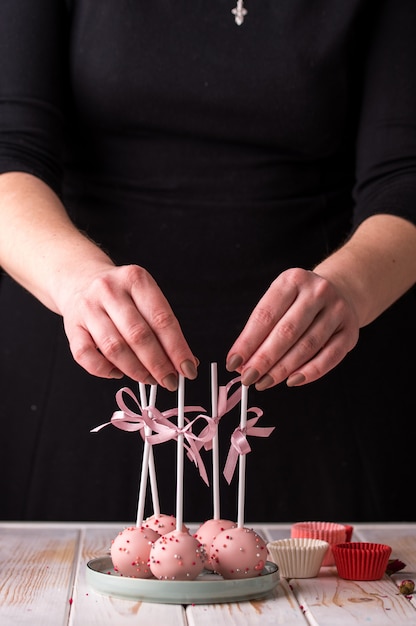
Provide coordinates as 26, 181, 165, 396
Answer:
0, 0, 416, 521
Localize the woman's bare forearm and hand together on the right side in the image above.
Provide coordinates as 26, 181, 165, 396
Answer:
227, 214, 416, 391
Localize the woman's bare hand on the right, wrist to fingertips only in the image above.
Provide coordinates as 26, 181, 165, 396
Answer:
227, 268, 359, 391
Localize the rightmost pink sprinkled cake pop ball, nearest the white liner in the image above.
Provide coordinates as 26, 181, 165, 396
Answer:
209, 527, 267, 579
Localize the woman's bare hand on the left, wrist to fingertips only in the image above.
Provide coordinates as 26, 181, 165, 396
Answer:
60, 261, 198, 391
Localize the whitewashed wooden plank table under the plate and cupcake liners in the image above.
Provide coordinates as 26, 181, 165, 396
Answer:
0, 522, 416, 626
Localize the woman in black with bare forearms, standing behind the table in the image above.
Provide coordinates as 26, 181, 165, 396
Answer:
0, 0, 416, 521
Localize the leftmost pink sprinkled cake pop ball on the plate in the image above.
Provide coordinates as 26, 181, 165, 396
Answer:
111, 526, 160, 578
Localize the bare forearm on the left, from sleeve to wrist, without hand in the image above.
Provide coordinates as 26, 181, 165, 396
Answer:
0, 172, 112, 313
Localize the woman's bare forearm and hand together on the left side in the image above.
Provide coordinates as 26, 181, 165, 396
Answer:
0, 172, 198, 391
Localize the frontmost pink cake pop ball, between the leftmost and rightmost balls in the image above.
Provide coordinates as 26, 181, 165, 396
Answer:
150, 530, 206, 580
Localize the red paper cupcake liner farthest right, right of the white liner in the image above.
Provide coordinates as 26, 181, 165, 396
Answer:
332, 541, 391, 580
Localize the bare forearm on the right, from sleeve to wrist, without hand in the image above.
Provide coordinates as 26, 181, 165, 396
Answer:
314, 215, 416, 327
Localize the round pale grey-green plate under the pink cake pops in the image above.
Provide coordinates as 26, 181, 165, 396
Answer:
87, 556, 280, 604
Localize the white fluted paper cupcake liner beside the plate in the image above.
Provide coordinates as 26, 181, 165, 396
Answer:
267, 537, 329, 578
